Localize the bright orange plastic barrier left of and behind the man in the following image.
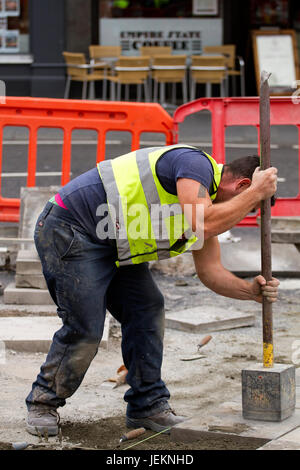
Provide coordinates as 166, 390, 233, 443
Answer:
0, 97, 173, 222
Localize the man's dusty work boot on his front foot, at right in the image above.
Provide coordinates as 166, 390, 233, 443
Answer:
126, 408, 187, 434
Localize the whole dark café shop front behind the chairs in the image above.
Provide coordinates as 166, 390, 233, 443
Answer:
0, 0, 300, 98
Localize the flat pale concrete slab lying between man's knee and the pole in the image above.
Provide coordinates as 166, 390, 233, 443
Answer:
165, 305, 255, 333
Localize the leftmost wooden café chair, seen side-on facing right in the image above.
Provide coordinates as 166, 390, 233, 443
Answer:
63, 52, 105, 99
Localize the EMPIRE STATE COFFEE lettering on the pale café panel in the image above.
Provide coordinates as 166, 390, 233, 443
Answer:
120, 31, 201, 53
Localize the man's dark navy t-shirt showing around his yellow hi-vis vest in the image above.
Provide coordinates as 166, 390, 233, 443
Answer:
59, 148, 213, 241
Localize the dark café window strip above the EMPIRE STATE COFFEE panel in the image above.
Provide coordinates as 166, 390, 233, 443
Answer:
99, 0, 219, 18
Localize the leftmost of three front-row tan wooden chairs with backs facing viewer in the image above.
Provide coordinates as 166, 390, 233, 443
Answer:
108, 56, 150, 101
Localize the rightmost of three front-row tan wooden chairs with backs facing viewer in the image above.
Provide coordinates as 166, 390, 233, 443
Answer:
190, 55, 227, 101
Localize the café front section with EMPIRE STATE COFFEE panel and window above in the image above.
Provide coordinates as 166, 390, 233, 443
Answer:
99, 0, 223, 56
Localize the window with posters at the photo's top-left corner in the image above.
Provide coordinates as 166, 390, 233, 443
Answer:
0, 0, 29, 54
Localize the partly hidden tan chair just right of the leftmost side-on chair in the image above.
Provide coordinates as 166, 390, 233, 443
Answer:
89, 45, 121, 100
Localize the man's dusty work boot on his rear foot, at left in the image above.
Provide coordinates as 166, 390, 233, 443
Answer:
26, 406, 59, 436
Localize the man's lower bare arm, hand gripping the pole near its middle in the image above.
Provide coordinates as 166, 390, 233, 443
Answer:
192, 237, 279, 303
